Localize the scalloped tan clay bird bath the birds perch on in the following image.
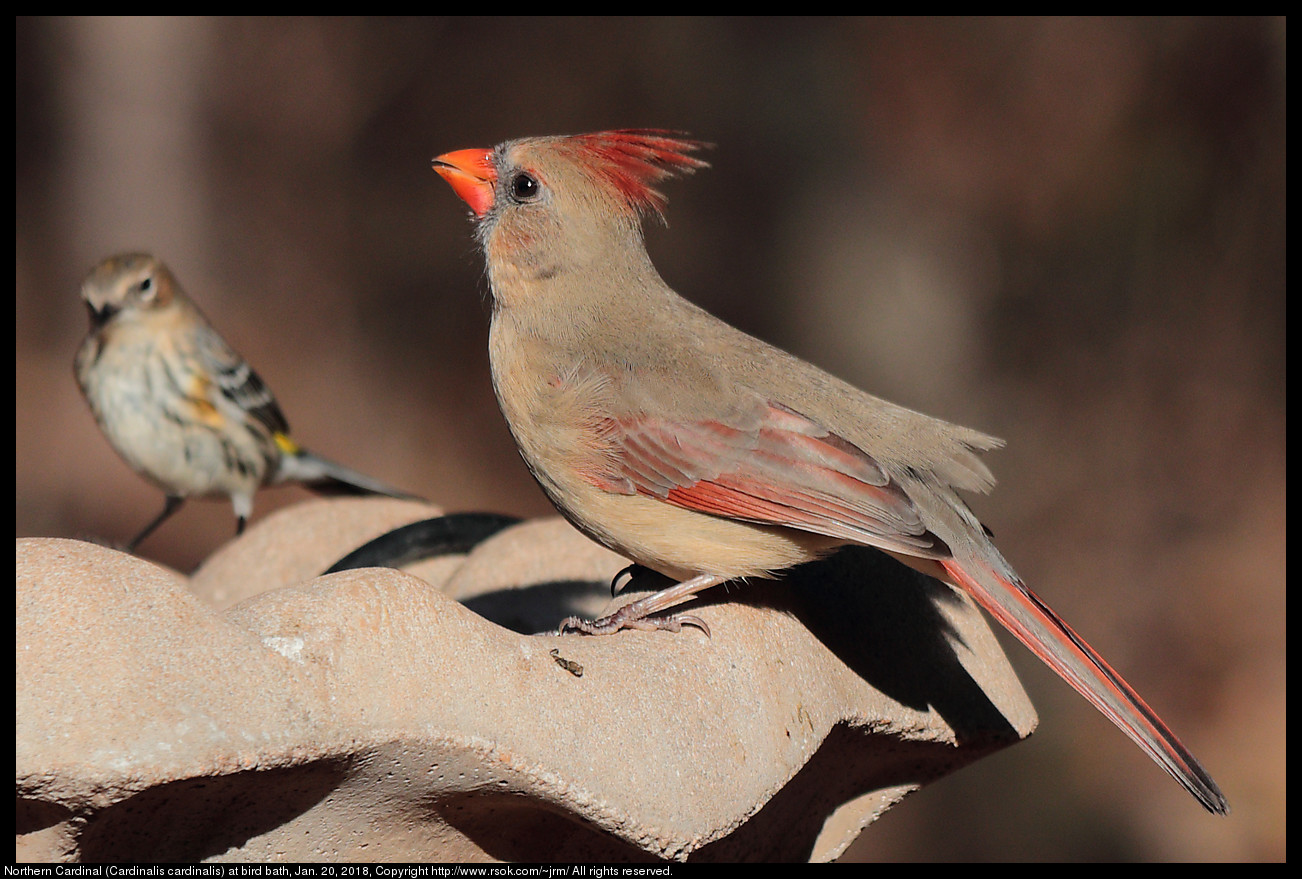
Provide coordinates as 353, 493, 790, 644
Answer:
16, 499, 1035, 862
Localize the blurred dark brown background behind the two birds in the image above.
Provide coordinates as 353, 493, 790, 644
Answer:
14, 18, 1286, 861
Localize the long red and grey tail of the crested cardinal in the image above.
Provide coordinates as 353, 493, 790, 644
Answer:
940, 559, 1229, 815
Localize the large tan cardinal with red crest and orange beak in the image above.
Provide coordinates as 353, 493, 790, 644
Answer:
434, 129, 1228, 814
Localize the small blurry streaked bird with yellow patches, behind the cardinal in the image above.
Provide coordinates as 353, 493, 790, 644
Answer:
74, 254, 413, 551
